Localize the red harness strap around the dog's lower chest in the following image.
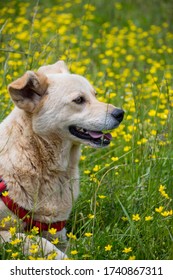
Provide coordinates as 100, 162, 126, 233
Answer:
0, 176, 66, 232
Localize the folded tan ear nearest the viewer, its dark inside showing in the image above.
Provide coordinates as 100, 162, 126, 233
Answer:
8, 71, 48, 113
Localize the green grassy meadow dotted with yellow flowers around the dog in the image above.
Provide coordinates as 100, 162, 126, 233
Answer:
0, 0, 173, 260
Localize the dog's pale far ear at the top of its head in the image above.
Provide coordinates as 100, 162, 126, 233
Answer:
38, 60, 69, 75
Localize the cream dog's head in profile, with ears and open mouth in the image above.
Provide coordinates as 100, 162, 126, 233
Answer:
8, 61, 124, 147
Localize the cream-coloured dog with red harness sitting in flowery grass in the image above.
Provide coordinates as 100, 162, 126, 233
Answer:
0, 61, 124, 259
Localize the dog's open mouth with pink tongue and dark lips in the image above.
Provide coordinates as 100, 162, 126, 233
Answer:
69, 126, 112, 146
